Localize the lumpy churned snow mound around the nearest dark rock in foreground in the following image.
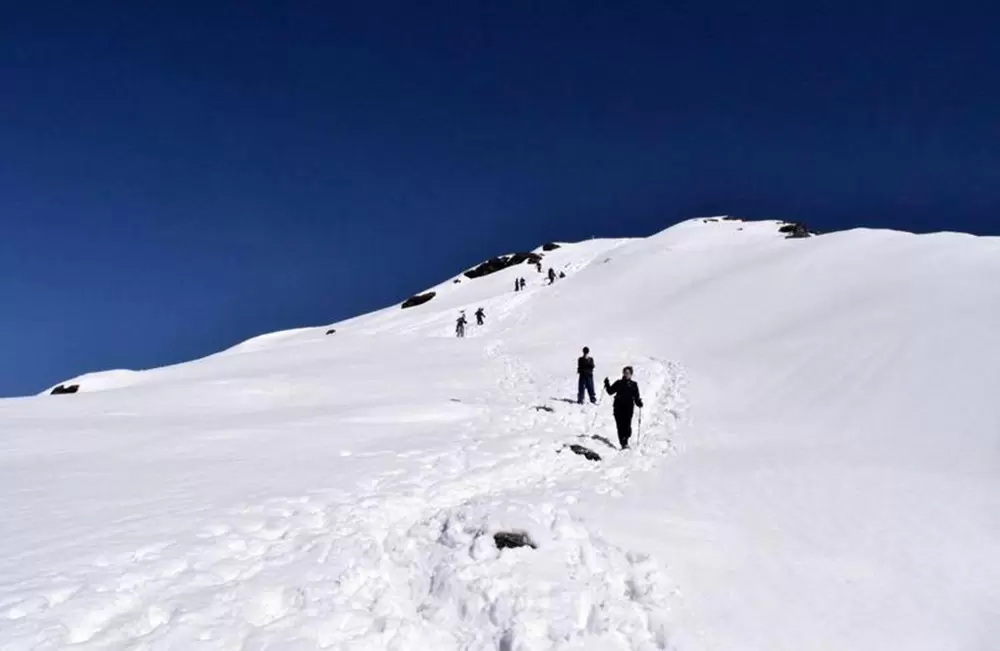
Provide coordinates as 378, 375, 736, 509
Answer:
410, 504, 671, 651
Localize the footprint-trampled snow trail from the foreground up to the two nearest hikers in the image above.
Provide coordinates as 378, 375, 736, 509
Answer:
0, 342, 682, 651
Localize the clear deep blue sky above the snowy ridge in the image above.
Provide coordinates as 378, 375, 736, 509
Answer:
0, 0, 1000, 395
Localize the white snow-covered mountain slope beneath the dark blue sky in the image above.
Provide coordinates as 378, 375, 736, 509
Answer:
0, 219, 1000, 651
